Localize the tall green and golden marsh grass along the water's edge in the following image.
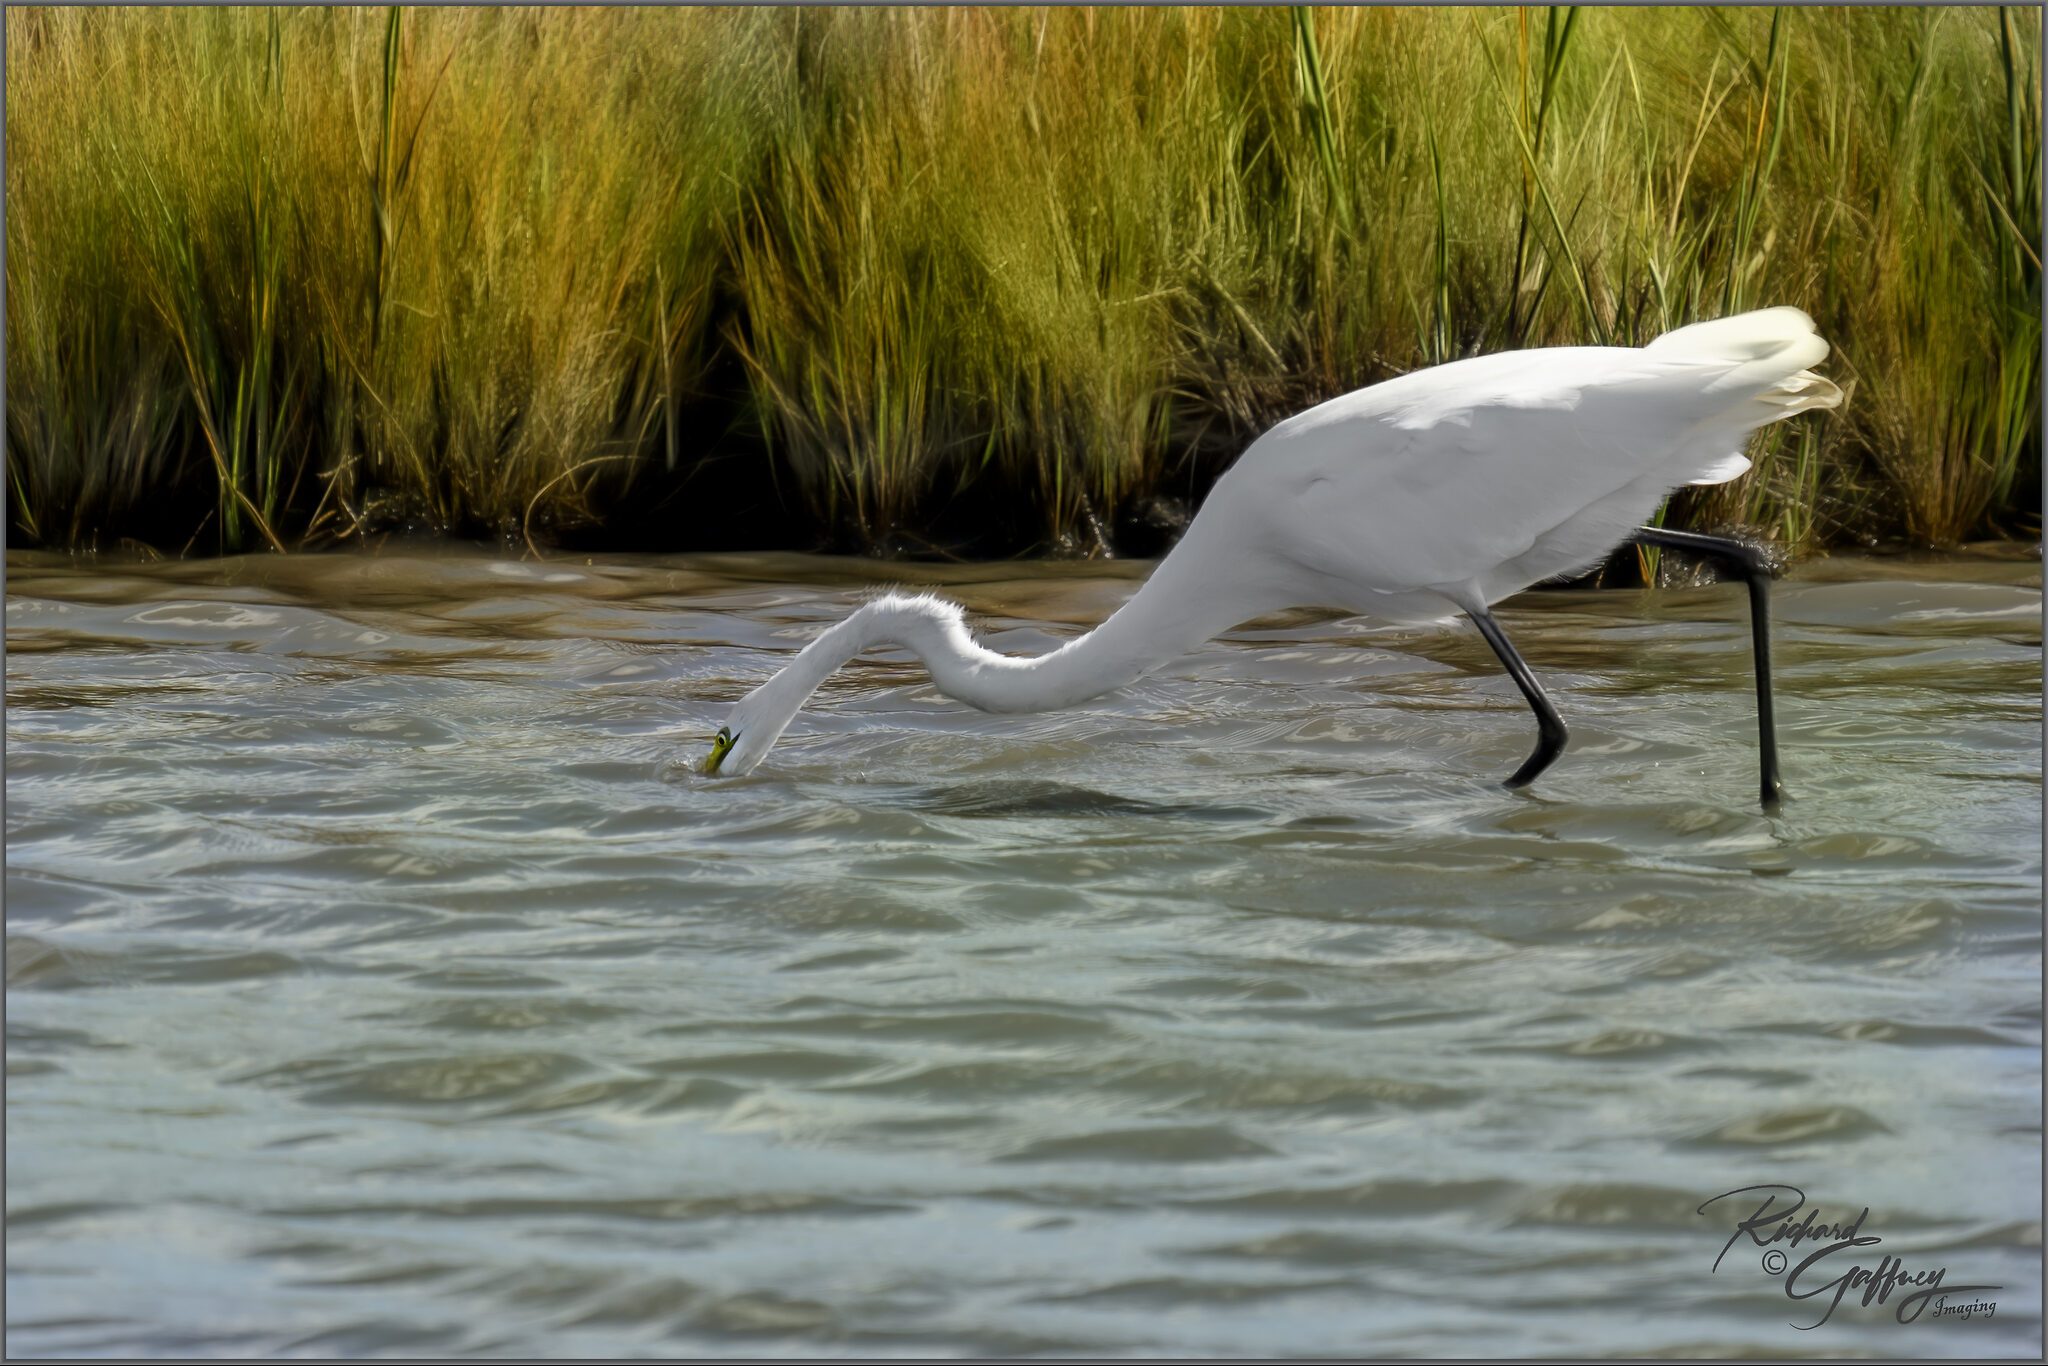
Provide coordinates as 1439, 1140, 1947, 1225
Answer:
6, 6, 2042, 551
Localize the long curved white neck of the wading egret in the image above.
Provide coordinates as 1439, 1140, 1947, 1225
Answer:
764, 555, 1260, 713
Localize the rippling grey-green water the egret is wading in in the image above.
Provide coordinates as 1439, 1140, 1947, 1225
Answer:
6, 553, 2042, 1356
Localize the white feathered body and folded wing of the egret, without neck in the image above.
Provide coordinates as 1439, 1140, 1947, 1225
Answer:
1204, 309, 1841, 600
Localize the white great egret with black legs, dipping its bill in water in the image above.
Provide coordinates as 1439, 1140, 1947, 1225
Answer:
705, 307, 1841, 807
